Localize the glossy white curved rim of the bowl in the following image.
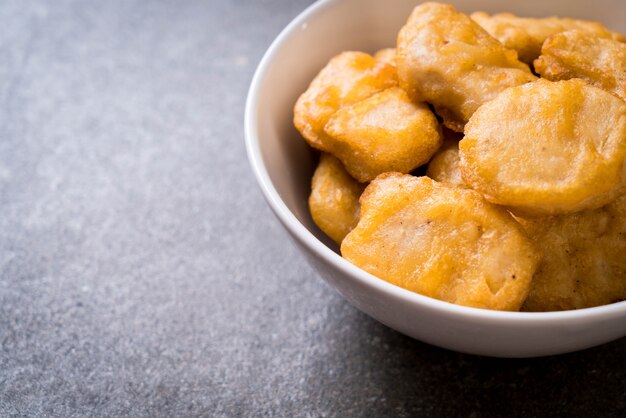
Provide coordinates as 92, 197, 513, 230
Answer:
244, 0, 626, 325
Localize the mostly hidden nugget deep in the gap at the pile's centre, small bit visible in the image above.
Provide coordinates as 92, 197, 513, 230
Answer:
426, 129, 467, 188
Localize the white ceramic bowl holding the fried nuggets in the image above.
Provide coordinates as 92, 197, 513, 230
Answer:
245, 0, 626, 357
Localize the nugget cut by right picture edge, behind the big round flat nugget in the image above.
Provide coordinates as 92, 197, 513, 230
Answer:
535, 31, 626, 100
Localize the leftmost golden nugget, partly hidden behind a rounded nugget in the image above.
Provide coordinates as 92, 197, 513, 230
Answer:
293, 51, 397, 151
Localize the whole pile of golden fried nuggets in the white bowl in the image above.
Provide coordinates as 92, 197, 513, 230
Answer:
294, 3, 626, 311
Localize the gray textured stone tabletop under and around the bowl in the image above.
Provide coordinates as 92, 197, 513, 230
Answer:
0, 0, 626, 417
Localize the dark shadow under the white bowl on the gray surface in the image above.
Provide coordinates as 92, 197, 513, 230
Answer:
307, 301, 626, 417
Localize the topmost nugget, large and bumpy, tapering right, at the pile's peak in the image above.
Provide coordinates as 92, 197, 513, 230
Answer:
396, 3, 536, 132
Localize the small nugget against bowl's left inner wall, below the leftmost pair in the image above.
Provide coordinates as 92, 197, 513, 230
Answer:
309, 153, 365, 244
